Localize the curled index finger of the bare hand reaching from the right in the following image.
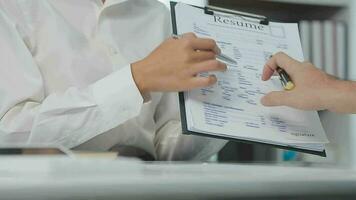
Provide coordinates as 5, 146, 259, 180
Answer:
262, 52, 298, 80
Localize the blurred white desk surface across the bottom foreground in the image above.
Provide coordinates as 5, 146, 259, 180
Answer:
0, 157, 356, 200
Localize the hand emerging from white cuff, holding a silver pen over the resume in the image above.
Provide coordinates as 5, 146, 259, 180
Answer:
131, 33, 226, 94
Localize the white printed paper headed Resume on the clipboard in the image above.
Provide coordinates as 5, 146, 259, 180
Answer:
176, 3, 328, 151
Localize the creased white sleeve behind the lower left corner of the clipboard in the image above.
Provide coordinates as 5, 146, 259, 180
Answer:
155, 93, 227, 161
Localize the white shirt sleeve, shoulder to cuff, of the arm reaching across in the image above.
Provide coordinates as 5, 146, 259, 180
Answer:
0, 9, 143, 148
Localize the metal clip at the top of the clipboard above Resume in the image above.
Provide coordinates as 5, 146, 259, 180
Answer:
204, 5, 269, 25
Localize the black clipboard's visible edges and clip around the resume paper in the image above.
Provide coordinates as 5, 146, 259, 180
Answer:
170, 1, 326, 157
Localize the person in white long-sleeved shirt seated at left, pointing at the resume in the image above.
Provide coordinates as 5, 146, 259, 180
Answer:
0, 0, 226, 160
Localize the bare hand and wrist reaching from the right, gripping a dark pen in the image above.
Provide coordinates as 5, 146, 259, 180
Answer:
261, 53, 356, 112
